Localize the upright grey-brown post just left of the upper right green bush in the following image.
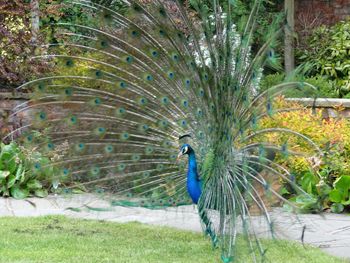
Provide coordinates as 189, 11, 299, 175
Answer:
284, 0, 295, 74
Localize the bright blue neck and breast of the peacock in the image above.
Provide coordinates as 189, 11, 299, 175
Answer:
187, 150, 202, 204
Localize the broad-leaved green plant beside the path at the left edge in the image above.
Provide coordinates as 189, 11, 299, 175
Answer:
0, 142, 52, 199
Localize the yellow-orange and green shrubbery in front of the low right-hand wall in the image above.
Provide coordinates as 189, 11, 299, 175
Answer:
260, 99, 350, 212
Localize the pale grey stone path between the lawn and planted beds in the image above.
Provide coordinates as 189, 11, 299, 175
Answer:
0, 194, 350, 262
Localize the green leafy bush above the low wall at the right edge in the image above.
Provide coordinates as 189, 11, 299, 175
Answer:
300, 20, 350, 98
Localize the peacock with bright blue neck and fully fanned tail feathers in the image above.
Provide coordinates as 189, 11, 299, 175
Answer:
5, 0, 319, 262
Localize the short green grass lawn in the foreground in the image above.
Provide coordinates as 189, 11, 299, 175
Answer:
0, 216, 349, 263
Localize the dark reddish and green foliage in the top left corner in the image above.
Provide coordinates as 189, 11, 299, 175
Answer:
0, 0, 124, 87
